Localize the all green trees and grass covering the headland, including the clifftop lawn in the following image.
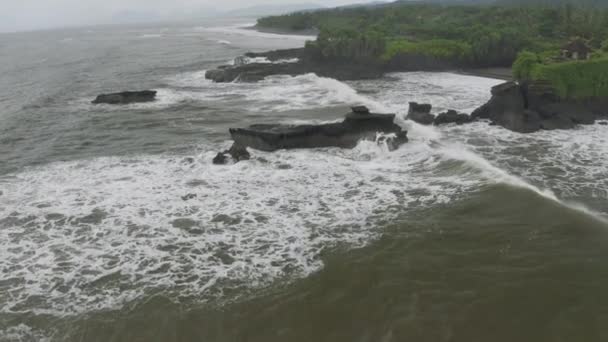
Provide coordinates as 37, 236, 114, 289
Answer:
258, 0, 608, 98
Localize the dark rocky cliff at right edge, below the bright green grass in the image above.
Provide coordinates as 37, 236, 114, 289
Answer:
471, 82, 608, 133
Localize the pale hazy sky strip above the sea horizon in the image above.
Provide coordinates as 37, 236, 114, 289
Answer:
0, 0, 365, 31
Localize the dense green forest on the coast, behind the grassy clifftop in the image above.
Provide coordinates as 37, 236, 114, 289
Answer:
258, 0, 608, 66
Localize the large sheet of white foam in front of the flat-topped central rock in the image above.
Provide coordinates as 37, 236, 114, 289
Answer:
0, 138, 477, 315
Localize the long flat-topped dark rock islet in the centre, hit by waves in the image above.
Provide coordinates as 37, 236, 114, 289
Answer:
230, 107, 407, 151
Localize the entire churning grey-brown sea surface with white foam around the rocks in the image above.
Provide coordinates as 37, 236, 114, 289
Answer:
0, 21, 608, 342
